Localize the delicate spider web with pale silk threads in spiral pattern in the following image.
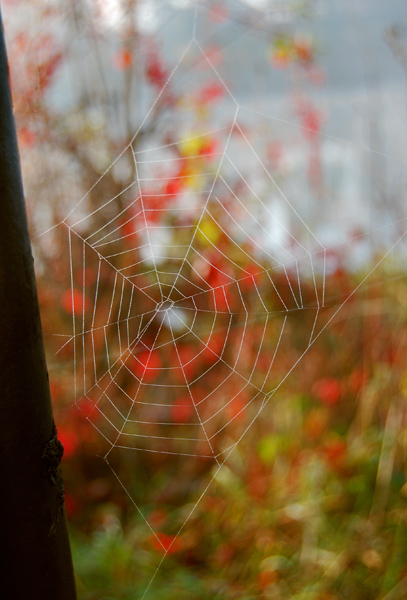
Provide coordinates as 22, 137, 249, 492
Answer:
39, 3, 406, 597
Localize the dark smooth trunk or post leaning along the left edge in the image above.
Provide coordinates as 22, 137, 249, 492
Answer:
0, 9, 76, 600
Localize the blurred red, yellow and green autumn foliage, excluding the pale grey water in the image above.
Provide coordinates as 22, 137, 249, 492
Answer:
3, 2, 407, 600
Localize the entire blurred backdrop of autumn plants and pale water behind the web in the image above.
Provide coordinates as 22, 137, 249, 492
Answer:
2, 0, 407, 600
